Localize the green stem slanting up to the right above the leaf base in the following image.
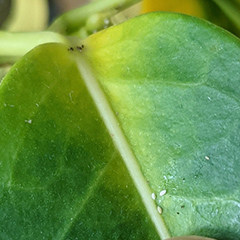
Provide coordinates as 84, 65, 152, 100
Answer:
49, 0, 140, 34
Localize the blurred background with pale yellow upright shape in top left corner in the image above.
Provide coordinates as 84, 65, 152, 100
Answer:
0, 0, 89, 31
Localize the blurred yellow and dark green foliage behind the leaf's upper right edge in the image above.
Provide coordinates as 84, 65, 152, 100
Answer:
142, 0, 240, 37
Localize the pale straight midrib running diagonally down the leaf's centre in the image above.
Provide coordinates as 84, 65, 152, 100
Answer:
76, 55, 170, 239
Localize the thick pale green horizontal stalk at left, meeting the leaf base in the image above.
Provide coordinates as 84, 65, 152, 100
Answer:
0, 31, 68, 63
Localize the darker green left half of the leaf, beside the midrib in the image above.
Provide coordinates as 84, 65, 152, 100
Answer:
0, 44, 158, 239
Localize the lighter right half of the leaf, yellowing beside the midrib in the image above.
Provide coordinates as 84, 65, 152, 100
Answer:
83, 13, 240, 239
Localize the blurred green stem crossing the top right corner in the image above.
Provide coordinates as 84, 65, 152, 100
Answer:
213, 0, 240, 29
